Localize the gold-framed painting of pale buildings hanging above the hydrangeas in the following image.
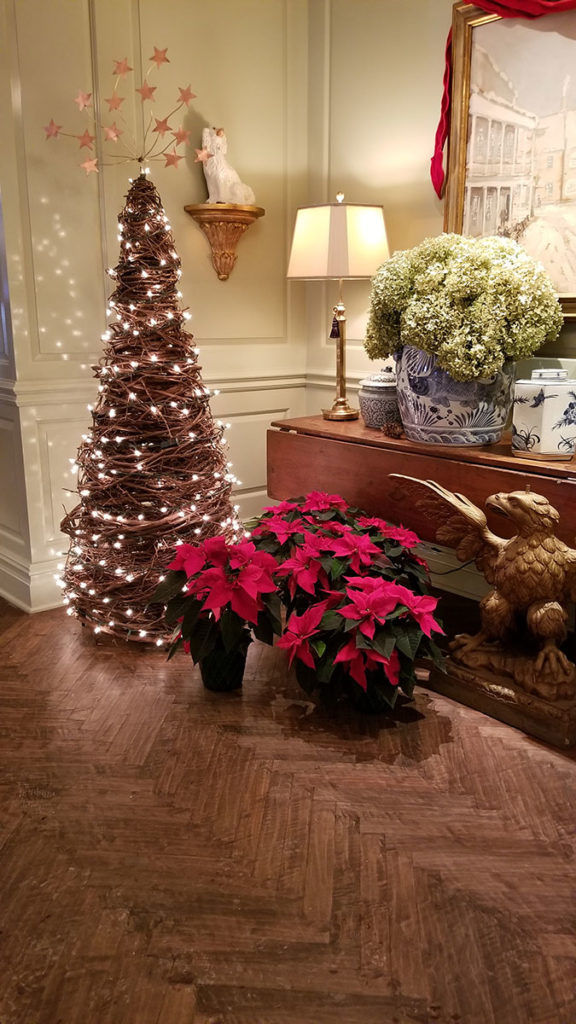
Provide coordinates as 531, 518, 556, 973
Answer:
444, 3, 576, 318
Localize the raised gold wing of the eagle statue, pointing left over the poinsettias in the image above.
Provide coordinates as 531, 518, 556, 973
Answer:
389, 473, 507, 584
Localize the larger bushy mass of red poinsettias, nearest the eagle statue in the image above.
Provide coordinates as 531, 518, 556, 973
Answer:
243, 492, 443, 709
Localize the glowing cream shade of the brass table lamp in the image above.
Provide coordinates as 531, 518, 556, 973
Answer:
287, 203, 389, 281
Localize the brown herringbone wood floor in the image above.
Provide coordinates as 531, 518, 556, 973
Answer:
0, 604, 576, 1024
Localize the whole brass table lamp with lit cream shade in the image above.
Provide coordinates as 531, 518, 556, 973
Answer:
287, 193, 389, 420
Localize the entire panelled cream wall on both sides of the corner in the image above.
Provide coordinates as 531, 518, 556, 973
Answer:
0, 0, 570, 609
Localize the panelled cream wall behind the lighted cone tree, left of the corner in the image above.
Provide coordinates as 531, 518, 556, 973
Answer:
0, 0, 307, 609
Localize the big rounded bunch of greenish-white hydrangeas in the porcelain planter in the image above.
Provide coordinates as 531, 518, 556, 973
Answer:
365, 234, 563, 381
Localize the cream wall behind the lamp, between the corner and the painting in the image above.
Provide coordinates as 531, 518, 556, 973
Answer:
299, 0, 576, 413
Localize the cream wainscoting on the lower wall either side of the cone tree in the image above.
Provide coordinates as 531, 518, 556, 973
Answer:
7, 376, 305, 611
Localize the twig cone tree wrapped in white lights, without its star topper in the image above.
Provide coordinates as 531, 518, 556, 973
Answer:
60, 173, 244, 646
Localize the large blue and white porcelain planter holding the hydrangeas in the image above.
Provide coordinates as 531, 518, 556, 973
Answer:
396, 345, 513, 444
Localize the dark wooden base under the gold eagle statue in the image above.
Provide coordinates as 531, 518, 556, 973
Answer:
425, 657, 576, 749
